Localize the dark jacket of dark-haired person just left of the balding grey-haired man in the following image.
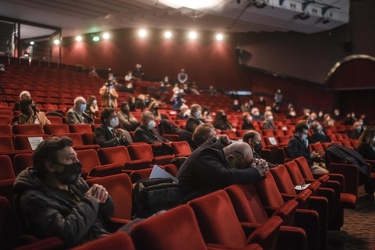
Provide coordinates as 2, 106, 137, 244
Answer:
94, 125, 132, 148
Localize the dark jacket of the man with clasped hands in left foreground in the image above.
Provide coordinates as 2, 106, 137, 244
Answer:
14, 168, 114, 246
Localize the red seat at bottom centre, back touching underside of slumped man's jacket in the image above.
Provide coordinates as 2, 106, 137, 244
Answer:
188, 190, 282, 249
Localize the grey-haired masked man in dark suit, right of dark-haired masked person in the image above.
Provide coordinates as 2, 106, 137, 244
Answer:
134, 111, 173, 156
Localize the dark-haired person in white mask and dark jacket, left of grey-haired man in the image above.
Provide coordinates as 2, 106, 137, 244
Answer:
94, 108, 133, 148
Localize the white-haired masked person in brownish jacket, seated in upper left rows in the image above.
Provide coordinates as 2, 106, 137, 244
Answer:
66, 96, 94, 124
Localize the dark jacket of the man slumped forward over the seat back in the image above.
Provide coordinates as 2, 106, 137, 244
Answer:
177, 138, 261, 201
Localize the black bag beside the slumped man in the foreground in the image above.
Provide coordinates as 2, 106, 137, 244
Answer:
133, 178, 182, 218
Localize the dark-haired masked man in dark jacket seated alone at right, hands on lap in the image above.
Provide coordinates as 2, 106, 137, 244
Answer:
288, 122, 328, 174
